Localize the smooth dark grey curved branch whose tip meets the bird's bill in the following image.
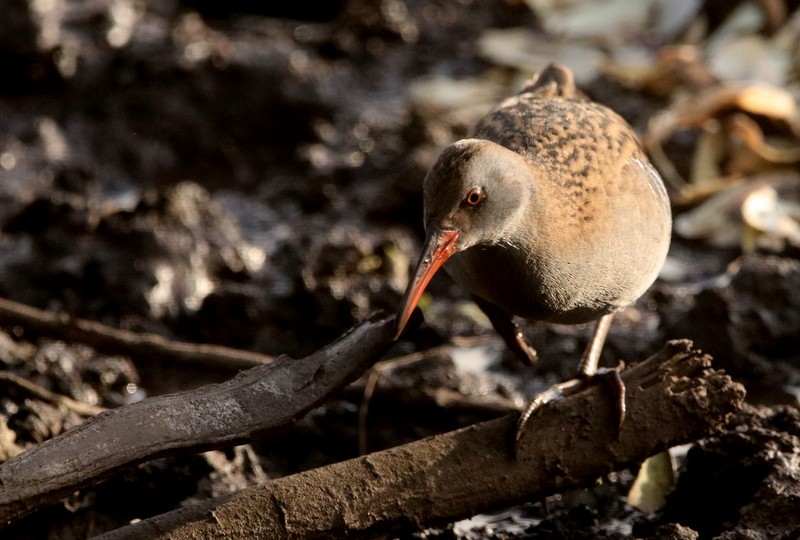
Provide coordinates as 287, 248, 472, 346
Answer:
0, 310, 394, 523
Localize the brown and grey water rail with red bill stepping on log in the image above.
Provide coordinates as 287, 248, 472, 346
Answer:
395, 63, 672, 444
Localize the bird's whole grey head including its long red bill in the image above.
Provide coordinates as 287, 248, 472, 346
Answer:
396, 139, 535, 336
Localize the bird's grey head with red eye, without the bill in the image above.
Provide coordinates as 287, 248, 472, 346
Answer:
424, 139, 535, 251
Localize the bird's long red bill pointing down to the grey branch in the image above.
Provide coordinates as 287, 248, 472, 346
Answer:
394, 229, 458, 339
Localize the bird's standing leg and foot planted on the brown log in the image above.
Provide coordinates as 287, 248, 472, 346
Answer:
514, 313, 625, 448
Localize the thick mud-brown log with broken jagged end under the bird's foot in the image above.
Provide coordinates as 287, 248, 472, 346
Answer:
102, 341, 744, 540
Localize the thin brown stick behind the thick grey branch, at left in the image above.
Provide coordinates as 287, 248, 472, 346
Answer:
0, 298, 273, 371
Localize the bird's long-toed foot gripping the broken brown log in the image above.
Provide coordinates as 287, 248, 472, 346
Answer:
514, 363, 626, 454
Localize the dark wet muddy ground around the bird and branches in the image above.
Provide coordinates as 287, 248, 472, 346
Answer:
0, 0, 800, 539
